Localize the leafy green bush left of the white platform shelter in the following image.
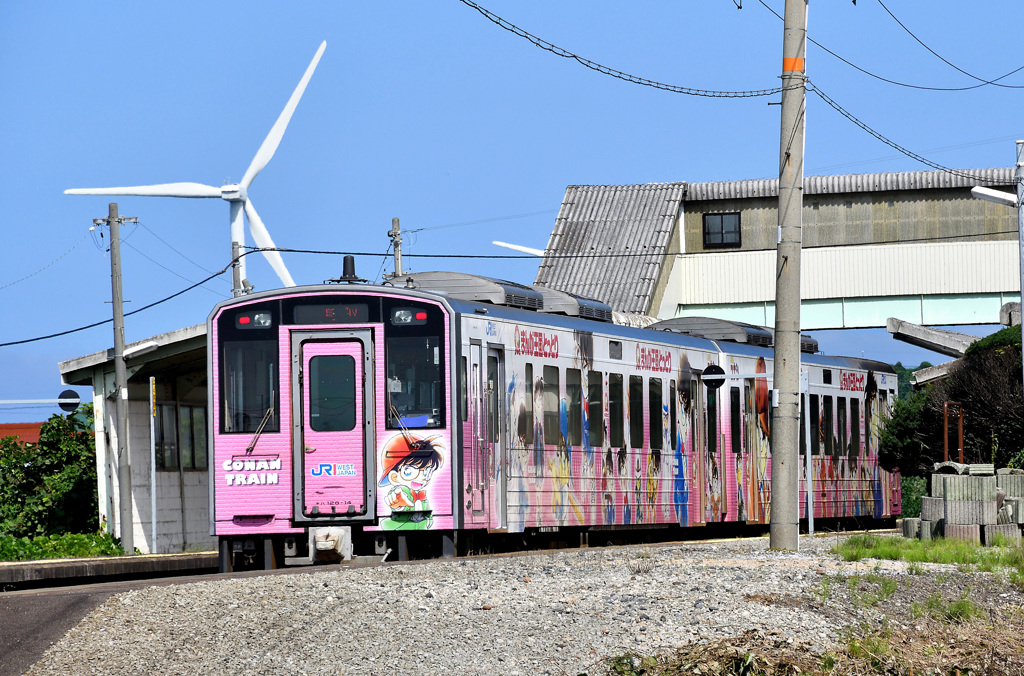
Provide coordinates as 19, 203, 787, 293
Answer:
0, 405, 97, 538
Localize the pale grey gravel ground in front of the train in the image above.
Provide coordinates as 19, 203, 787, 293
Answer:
29, 537, 1021, 676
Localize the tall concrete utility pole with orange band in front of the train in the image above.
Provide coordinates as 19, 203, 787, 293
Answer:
769, 0, 810, 550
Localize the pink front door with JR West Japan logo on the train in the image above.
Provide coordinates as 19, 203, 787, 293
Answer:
292, 331, 375, 521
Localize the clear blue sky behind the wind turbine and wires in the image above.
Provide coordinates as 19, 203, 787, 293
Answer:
0, 0, 1024, 422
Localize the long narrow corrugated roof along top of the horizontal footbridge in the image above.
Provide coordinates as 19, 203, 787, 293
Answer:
686, 167, 1014, 202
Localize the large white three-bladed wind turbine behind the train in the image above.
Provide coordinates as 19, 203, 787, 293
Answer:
65, 41, 327, 295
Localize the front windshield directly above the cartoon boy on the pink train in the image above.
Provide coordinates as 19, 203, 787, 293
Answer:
385, 336, 444, 428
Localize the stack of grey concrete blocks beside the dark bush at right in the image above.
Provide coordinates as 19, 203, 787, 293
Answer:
903, 462, 1024, 545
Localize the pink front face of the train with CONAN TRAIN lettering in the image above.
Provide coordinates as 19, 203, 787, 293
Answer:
208, 286, 454, 571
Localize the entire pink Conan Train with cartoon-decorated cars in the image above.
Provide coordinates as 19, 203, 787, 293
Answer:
208, 272, 900, 569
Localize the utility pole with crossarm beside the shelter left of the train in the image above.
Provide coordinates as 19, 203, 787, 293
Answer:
92, 202, 138, 556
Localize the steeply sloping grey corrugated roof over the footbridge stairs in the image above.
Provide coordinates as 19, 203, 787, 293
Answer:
537, 182, 686, 313
